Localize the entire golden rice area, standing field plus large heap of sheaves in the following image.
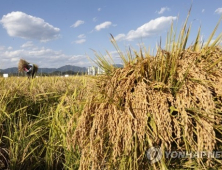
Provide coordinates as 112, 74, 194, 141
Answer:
0, 11, 222, 170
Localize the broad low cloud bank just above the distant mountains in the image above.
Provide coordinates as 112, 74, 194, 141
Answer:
0, 47, 90, 68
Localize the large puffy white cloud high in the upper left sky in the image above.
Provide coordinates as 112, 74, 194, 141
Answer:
0, 11, 60, 42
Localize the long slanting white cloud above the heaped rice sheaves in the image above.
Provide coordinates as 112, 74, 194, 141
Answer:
115, 16, 177, 41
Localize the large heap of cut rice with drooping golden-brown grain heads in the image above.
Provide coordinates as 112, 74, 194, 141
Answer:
73, 44, 222, 169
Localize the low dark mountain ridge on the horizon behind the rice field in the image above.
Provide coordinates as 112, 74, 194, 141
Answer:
0, 65, 87, 73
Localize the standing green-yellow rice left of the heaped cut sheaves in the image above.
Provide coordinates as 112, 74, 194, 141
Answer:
0, 76, 94, 170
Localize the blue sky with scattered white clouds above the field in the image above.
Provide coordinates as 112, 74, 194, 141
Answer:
0, 0, 222, 69
